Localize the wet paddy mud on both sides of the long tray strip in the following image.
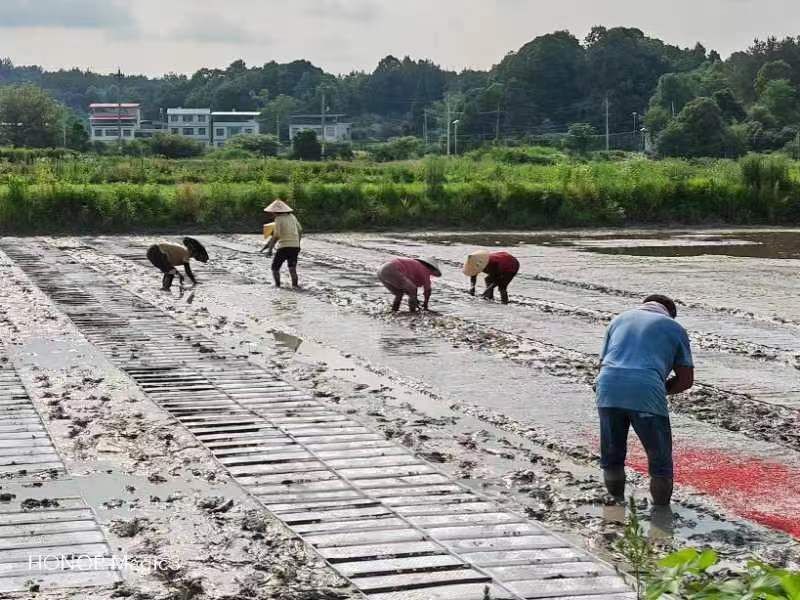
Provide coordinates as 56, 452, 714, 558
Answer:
0, 230, 800, 598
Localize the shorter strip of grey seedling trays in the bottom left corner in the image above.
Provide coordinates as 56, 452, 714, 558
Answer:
0, 344, 120, 594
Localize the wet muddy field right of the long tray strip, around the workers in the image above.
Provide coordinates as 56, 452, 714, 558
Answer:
4, 227, 800, 580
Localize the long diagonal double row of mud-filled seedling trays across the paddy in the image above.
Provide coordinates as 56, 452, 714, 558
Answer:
4, 244, 635, 598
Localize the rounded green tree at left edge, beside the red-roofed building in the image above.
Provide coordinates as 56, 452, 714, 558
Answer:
0, 85, 64, 148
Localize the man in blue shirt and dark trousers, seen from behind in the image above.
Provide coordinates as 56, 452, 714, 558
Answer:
596, 294, 694, 506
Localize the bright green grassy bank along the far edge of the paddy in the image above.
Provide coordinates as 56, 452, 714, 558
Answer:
0, 154, 800, 234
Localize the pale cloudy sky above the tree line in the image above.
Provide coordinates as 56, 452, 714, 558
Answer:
0, 0, 800, 76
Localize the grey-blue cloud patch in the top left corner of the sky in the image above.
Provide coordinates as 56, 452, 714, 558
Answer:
0, 0, 133, 29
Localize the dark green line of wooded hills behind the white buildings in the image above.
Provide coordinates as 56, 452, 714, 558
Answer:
0, 27, 800, 156
